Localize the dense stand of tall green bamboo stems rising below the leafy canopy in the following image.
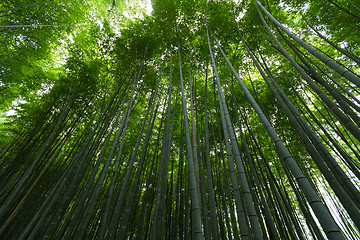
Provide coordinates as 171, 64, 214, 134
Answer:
0, 0, 360, 239
